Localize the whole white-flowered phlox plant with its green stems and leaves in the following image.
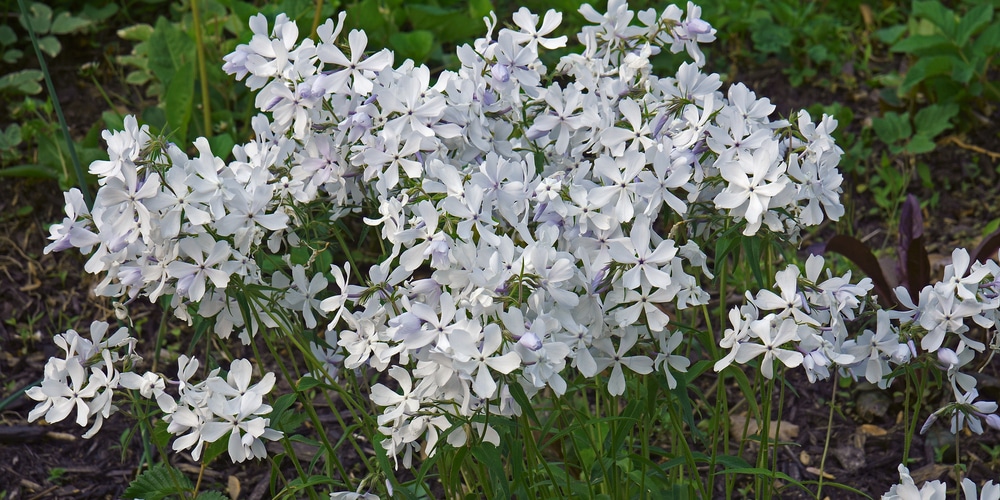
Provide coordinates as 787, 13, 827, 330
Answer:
28, 0, 1000, 498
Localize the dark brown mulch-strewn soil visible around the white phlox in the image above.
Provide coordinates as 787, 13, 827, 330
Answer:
0, 11, 1000, 499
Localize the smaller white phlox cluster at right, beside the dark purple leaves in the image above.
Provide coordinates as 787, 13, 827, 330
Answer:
715, 248, 1000, 434
